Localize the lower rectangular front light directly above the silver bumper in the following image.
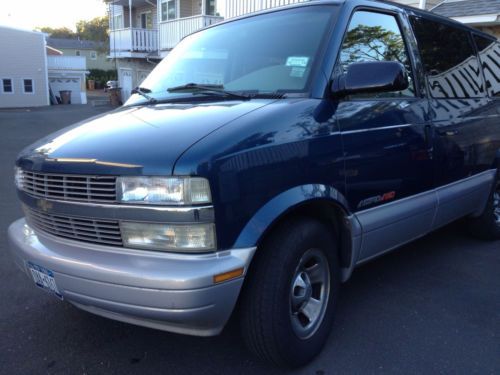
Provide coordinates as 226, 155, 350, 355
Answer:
120, 222, 216, 252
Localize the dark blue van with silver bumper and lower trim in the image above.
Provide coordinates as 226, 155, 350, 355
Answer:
9, 0, 500, 367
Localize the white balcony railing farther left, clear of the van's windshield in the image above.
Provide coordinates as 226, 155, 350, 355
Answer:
109, 28, 158, 52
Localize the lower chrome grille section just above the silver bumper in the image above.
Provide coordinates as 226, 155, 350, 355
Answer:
24, 206, 122, 246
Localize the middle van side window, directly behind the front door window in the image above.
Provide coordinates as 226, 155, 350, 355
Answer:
411, 17, 485, 99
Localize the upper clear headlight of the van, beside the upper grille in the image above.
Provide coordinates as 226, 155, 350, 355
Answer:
117, 177, 212, 205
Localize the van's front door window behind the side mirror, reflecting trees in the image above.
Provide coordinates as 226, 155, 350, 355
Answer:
340, 11, 415, 97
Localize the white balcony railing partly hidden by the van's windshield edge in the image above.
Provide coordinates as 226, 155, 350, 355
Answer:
160, 15, 224, 50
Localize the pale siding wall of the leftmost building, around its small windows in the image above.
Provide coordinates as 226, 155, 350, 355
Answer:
0, 27, 49, 108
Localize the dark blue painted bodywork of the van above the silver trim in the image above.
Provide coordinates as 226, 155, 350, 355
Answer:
17, 1, 500, 253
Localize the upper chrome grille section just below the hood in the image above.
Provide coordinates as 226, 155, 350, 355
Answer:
19, 170, 116, 203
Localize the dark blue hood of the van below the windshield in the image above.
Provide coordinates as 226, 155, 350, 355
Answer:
17, 99, 273, 175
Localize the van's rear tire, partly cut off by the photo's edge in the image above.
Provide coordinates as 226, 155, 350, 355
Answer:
467, 177, 500, 241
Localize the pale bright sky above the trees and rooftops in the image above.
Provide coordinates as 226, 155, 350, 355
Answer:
0, 0, 106, 30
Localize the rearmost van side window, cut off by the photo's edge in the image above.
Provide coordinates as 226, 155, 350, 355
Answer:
474, 34, 500, 98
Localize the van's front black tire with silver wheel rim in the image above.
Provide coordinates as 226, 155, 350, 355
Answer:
240, 218, 340, 368
